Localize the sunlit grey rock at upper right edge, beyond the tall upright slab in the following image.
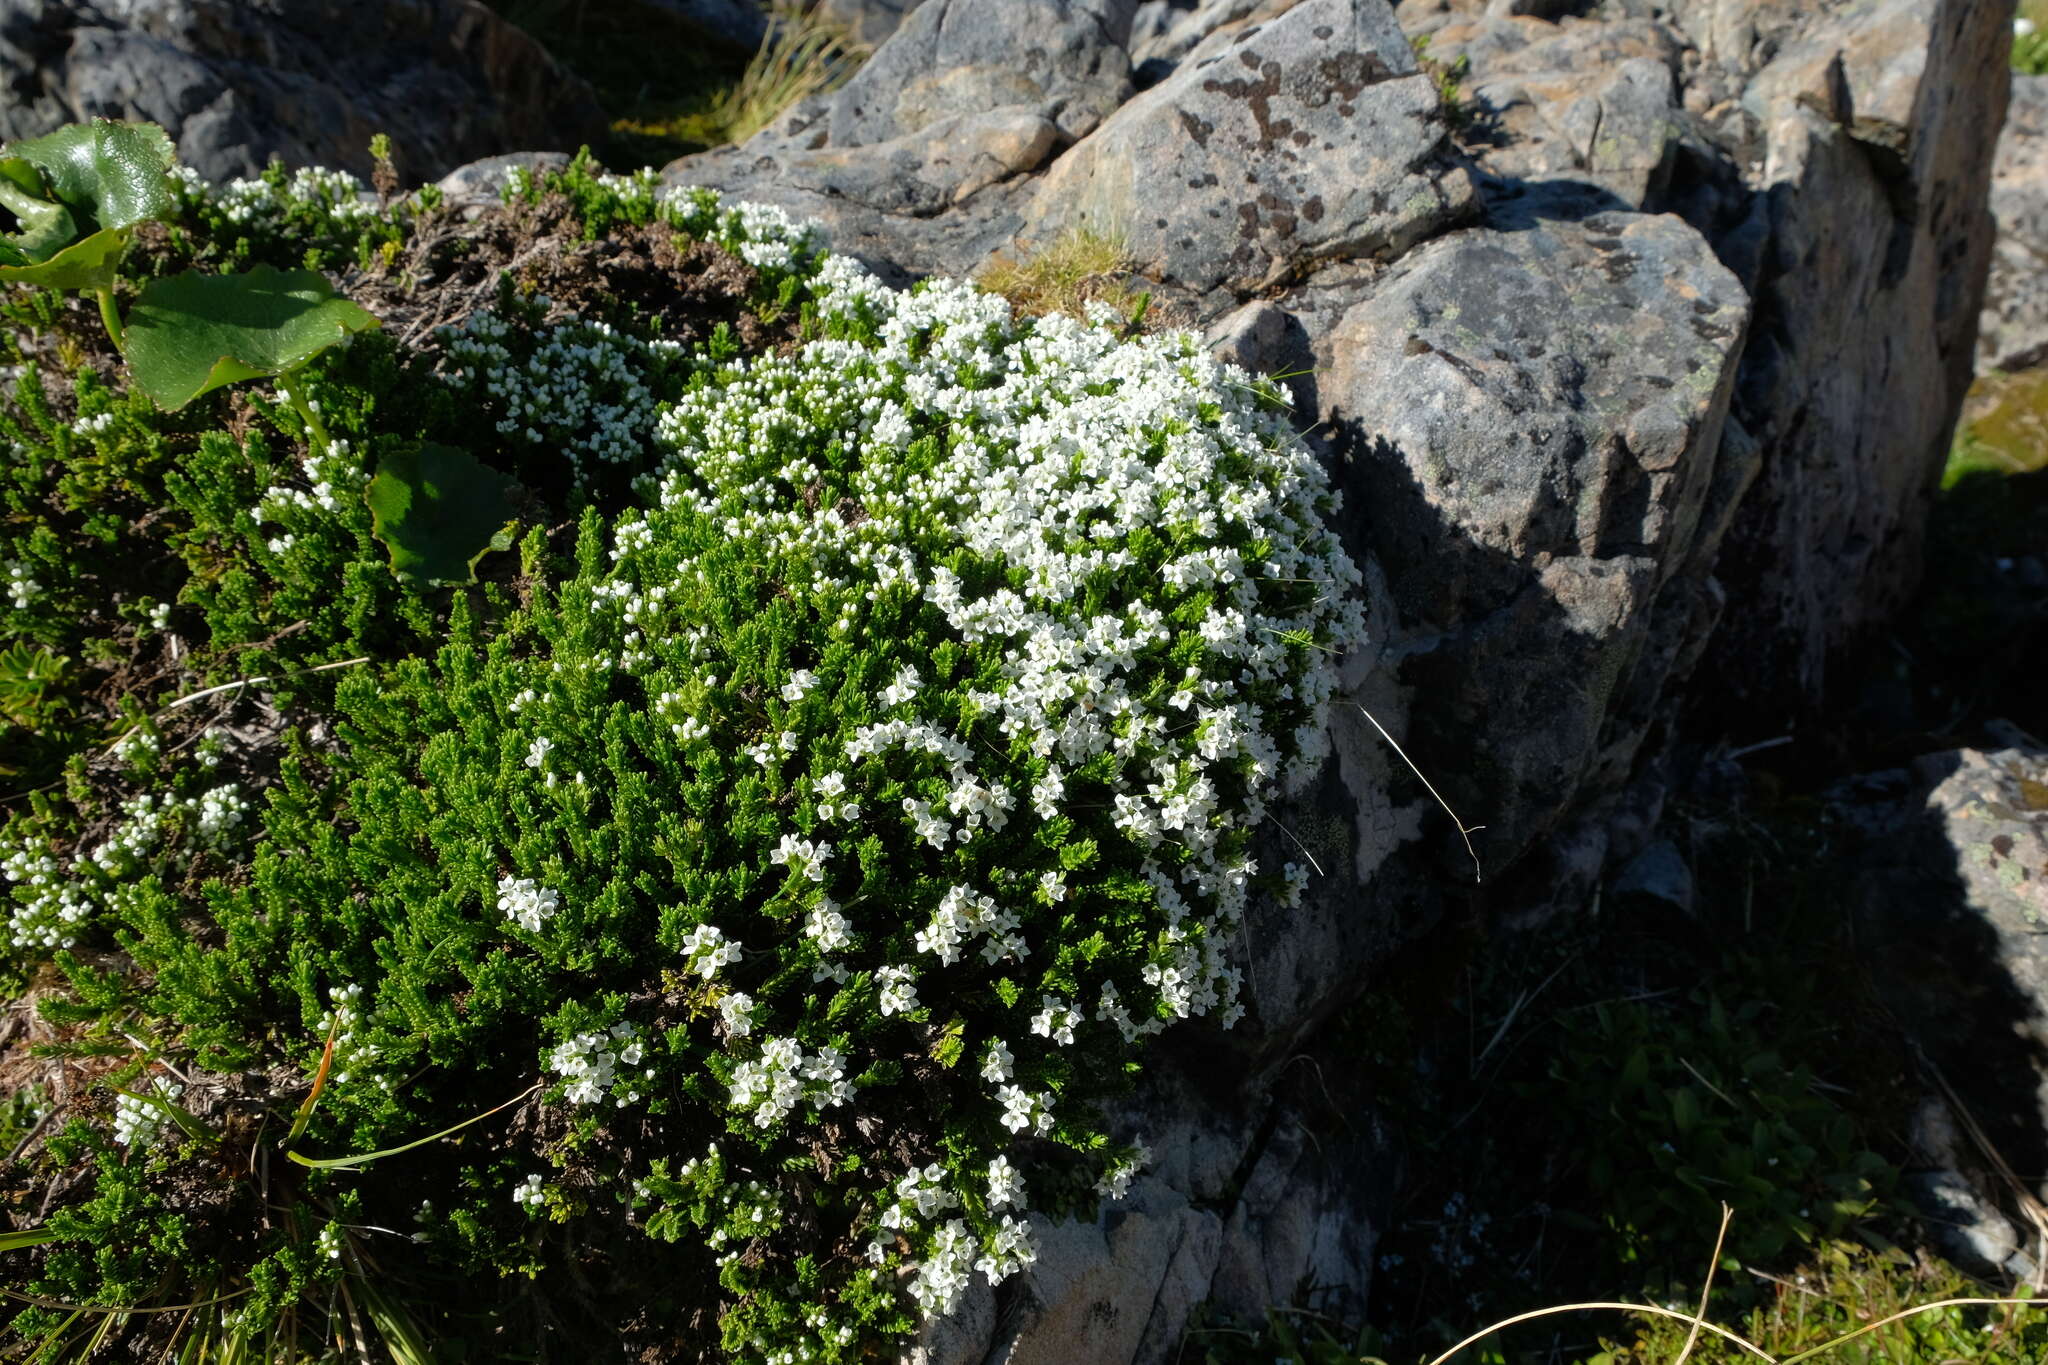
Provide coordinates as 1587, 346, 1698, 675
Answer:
1976, 76, 2048, 370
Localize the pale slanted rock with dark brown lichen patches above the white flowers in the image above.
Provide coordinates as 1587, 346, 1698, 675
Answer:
1026, 0, 1475, 293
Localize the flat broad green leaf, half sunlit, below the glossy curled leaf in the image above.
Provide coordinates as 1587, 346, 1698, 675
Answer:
127, 266, 377, 411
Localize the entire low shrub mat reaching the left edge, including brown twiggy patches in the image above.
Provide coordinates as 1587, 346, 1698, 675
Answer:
0, 133, 1362, 1361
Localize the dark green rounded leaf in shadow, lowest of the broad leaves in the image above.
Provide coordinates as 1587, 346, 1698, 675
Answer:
367, 442, 516, 583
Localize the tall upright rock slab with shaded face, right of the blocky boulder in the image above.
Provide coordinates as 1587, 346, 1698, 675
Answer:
1706, 0, 2011, 714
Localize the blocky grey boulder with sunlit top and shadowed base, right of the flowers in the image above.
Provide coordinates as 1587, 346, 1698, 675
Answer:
1317, 213, 1749, 866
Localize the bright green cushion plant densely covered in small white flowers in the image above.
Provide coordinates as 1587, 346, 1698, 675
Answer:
6, 144, 1362, 1361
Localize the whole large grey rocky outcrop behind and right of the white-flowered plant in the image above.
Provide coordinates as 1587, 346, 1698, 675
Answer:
448, 0, 2009, 1365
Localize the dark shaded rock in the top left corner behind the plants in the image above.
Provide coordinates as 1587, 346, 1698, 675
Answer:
0, 0, 604, 180
